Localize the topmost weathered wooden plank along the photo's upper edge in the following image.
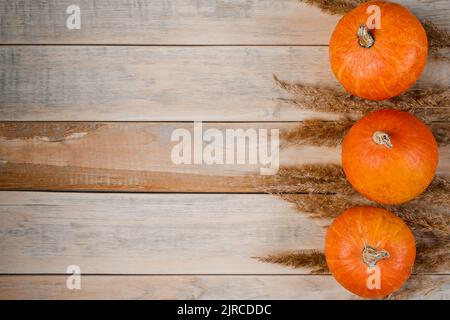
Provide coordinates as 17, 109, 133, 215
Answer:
0, 0, 450, 45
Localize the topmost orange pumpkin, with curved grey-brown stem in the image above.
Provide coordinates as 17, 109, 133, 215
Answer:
329, 1, 428, 100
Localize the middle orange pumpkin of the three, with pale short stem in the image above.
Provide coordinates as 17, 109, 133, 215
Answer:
342, 109, 439, 204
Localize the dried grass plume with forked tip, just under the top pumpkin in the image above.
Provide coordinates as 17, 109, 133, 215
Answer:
273, 75, 450, 122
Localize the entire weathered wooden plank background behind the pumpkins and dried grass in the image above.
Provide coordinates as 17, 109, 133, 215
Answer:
0, 0, 450, 299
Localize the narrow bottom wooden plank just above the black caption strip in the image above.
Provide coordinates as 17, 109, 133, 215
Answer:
0, 275, 450, 300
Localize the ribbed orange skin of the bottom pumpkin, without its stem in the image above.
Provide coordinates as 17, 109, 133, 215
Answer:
325, 206, 416, 298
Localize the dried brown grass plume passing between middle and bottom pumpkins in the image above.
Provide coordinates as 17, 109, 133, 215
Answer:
271, 172, 450, 238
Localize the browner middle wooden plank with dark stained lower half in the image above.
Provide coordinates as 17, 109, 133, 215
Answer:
0, 122, 450, 192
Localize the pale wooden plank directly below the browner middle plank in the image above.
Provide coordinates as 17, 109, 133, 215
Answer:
0, 192, 325, 274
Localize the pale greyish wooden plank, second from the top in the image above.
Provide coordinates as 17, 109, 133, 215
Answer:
0, 46, 450, 121
